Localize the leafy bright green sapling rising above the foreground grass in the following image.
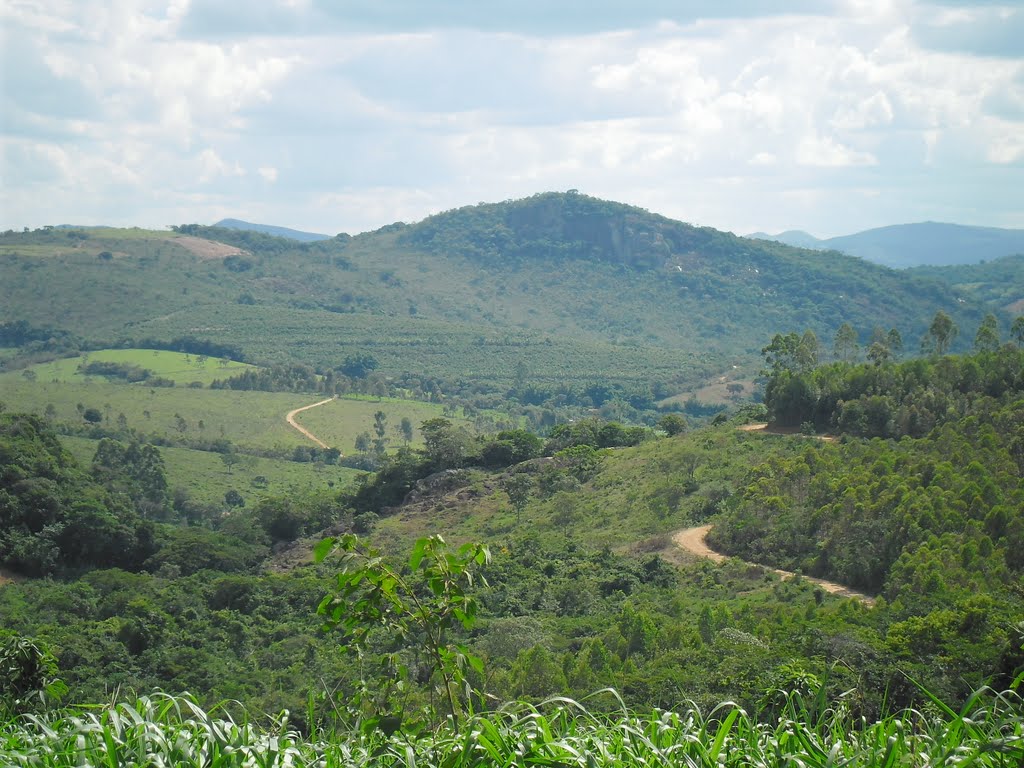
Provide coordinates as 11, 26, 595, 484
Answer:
314, 534, 490, 731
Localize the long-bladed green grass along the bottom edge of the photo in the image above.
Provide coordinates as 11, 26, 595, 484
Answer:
0, 690, 1024, 768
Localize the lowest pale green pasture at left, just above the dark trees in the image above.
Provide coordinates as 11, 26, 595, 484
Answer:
60, 436, 362, 504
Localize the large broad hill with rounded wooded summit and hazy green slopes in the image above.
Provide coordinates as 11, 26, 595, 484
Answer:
0, 193, 987, 402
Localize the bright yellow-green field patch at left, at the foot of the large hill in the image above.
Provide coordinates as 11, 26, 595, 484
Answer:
22, 349, 253, 386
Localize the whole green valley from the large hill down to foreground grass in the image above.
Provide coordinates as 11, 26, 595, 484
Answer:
0, 193, 1024, 766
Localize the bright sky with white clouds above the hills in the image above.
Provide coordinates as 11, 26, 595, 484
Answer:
0, 0, 1024, 237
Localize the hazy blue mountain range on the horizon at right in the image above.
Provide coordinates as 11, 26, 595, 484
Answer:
746, 221, 1024, 269
